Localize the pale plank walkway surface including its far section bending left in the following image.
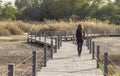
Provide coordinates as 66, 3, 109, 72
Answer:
28, 31, 104, 76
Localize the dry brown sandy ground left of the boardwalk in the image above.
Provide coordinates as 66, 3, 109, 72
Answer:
0, 35, 49, 76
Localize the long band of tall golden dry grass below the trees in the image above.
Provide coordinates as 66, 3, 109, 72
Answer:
0, 20, 120, 35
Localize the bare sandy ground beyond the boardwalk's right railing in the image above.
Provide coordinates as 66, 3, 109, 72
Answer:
93, 37, 120, 67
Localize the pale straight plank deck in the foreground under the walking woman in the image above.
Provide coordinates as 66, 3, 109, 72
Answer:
37, 42, 103, 76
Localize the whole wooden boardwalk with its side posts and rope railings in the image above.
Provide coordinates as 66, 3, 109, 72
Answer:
2, 32, 120, 76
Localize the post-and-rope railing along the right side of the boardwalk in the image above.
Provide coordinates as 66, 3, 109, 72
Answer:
86, 37, 120, 76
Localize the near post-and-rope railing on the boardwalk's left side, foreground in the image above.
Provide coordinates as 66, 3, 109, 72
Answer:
2, 44, 57, 76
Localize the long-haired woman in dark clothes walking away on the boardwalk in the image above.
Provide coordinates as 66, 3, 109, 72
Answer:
76, 24, 84, 56
